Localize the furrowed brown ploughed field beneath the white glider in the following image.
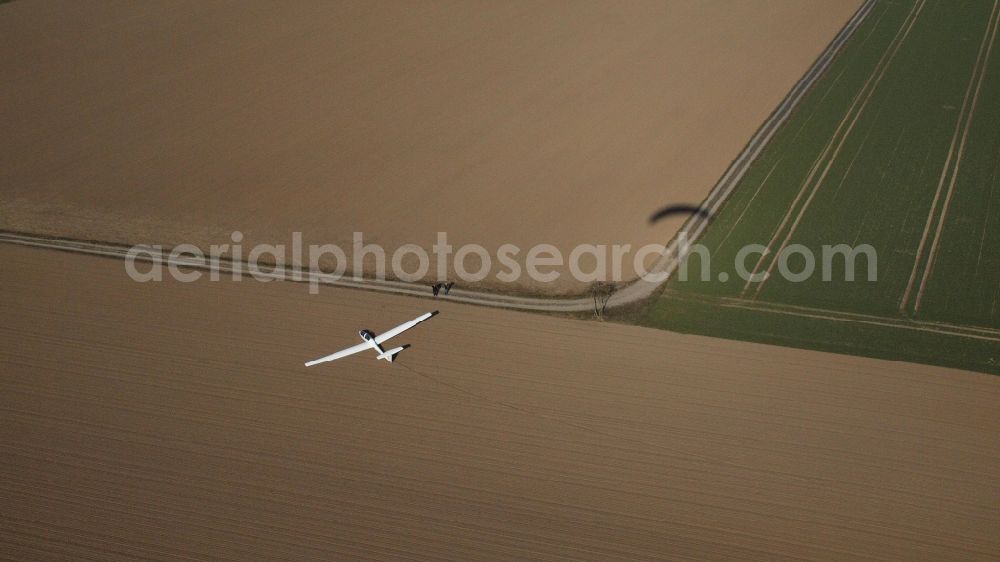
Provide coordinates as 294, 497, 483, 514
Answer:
0, 245, 1000, 560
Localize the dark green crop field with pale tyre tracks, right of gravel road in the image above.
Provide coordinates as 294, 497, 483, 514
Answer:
644, 0, 1000, 372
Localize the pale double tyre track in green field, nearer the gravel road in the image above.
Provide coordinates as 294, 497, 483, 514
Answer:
740, 0, 926, 299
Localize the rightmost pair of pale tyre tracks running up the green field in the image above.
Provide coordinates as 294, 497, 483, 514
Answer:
899, 0, 1000, 314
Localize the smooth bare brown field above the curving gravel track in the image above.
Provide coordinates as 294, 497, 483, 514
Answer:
0, 0, 860, 294
